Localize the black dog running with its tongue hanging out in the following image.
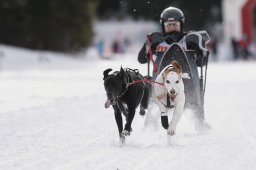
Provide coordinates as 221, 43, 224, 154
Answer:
103, 67, 151, 142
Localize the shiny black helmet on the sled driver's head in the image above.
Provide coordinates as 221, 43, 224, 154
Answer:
160, 7, 185, 32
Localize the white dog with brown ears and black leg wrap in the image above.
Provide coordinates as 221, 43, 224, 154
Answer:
154, 61, 188, 136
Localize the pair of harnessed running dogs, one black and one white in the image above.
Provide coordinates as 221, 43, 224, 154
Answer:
103, 61, 193, 142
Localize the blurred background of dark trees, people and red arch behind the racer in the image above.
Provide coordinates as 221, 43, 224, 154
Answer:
0, 0, 256, 61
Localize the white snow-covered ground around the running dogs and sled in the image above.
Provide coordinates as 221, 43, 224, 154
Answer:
0, 45, 256, 170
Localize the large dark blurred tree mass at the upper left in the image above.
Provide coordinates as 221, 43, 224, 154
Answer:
0, 0, 98, 51
